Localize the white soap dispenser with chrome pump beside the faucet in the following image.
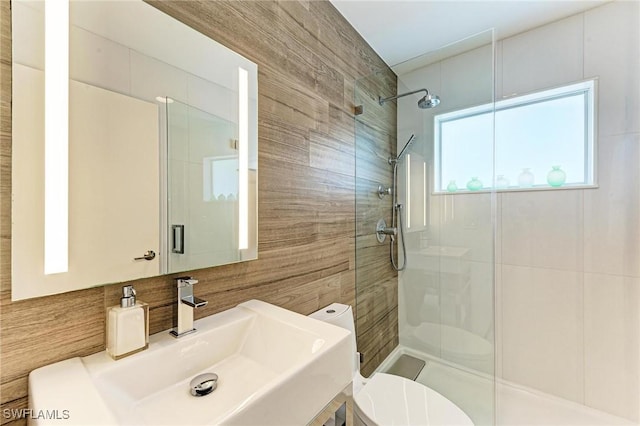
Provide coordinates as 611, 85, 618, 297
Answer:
107, 285, 149, 360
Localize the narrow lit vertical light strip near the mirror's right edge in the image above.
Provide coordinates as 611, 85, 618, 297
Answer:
238, 67, 249, 250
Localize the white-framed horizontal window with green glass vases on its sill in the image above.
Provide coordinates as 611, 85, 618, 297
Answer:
434, 80, 595, 192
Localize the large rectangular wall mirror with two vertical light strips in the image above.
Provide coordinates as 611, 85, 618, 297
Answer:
12, 0, 258, 300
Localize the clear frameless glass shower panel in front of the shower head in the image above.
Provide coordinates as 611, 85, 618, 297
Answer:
355, 31, 496, 424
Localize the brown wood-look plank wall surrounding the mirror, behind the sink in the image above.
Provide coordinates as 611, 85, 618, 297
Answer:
0, 0, 397, 424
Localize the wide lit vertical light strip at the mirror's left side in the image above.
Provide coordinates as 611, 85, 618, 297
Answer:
44, 0, 69, 274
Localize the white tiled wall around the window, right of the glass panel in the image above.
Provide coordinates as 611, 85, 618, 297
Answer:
496, 1, 640, 422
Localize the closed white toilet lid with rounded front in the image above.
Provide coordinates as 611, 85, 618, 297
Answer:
354, 373, 473, 426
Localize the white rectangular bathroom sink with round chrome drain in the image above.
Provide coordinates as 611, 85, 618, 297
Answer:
29, 300, 352, 426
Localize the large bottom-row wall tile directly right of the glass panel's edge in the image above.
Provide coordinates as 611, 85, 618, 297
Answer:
501, 265, 584, 402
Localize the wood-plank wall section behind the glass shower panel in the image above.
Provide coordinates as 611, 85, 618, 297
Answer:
354, 72, 398, 376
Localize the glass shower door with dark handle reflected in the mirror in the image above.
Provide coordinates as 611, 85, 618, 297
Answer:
166, 100, 257, 272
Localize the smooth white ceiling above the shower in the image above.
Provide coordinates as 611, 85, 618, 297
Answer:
330, 0, 609, 66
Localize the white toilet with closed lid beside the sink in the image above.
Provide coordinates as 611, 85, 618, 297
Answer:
309, 303, 473, 426
